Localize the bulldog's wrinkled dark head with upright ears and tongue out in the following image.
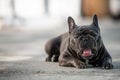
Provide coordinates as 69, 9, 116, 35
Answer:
68, 15, 101, 59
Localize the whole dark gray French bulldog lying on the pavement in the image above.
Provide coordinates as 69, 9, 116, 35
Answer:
45, 15, 113, 69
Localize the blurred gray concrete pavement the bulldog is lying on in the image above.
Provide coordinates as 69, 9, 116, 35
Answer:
0, 20, 120, 80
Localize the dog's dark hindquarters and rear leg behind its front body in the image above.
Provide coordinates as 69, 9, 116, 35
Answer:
45, 33, 68, 62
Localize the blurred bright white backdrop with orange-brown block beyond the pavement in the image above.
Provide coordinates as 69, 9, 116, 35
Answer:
0, 0, 120, 30
